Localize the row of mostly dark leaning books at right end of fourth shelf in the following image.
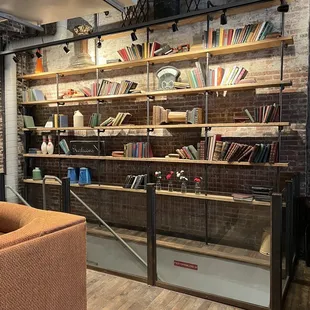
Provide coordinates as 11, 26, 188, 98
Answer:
197, 135, 279, 164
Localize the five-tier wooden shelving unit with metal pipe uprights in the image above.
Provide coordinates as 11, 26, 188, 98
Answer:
19, 12, 294, 252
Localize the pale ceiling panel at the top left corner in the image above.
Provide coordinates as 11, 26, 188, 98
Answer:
0, 0, 137, 25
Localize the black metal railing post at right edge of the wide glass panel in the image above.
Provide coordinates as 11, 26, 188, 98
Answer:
270, 193, 282, 310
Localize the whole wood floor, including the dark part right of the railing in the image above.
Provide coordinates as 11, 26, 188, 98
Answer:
87, 262, 310, 310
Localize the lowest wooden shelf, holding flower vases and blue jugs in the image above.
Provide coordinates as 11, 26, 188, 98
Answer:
24, 179, 271, 207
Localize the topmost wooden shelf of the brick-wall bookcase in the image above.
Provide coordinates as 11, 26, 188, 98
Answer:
19, 36, 294, 80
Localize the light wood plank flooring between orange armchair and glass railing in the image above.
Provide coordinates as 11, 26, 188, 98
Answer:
87, 270, 239, 310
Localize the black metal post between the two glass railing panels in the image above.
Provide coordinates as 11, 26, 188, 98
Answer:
146, 183, 157, 286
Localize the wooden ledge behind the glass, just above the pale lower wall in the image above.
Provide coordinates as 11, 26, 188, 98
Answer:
87, 224, 270, 268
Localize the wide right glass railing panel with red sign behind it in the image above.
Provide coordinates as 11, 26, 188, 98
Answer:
157, 167, 271, 307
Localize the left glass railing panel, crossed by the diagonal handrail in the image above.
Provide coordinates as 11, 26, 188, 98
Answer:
87, 161, 147, 278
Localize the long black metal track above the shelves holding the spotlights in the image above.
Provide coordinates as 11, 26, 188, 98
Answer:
0, 0, 273, 55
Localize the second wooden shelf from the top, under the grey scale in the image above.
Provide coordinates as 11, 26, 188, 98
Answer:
22, 80, 292, 105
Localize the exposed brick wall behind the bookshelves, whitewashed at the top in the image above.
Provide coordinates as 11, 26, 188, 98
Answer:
19, 0, 309, 249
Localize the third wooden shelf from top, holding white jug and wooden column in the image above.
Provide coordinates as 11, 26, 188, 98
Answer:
23, 122, 290, 132
